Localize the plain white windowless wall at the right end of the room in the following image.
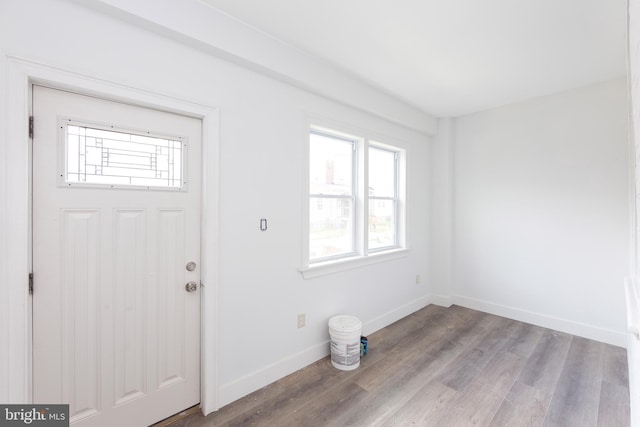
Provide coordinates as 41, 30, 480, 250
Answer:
451, 79, 629, 345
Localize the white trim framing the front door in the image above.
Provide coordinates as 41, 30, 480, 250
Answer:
0, 52, 219, 414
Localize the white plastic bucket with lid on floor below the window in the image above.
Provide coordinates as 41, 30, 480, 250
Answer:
329, 315, 362, 371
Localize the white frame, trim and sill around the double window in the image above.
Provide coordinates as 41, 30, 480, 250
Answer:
299, 121, 408, 279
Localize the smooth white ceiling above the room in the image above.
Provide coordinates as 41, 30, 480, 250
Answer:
203, 0, 627, 117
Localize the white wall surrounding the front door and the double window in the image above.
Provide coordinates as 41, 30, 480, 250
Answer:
0, 0, 430, 410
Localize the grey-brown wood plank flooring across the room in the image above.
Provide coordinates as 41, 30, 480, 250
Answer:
165, 305, 630, 427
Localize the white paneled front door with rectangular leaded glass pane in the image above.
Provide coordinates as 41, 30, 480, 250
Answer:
32, 86, 202, 426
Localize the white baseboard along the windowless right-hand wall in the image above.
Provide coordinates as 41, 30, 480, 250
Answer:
451, 295, 627, 347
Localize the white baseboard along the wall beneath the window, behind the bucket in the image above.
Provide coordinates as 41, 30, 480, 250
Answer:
218, 296, 430, 409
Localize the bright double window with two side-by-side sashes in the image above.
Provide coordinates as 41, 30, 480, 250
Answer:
304, 127, 405, 268
